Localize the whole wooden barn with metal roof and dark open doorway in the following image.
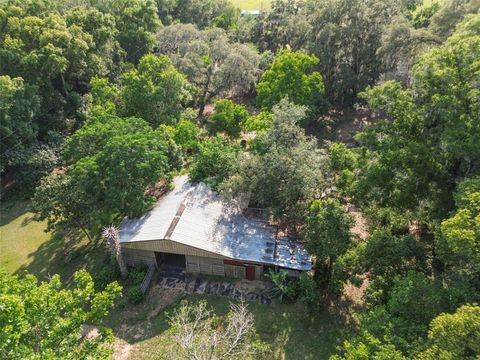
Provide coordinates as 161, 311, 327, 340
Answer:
119, 176, 312, 280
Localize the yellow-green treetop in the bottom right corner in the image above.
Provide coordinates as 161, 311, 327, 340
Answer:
417, 304, 480, 360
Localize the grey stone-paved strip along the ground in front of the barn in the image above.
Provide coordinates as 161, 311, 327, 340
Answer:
157, 268, 272, 305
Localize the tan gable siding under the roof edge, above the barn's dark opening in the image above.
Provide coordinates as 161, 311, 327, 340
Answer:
120, 240, 224, 259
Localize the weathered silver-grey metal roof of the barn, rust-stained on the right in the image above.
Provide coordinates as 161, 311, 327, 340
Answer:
120, 175, 312, 271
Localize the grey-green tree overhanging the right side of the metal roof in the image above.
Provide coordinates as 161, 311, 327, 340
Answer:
221, 100, 329, 228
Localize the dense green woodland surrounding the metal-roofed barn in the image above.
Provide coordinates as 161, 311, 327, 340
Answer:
0, 0, 480, 360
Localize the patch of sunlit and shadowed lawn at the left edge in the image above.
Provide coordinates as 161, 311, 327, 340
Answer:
0, 199, 108, 283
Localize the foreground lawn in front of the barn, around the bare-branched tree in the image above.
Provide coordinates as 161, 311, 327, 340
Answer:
108, 295, 351, 360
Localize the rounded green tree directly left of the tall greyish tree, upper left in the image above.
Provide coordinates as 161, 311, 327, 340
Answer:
121, 54, 190, 127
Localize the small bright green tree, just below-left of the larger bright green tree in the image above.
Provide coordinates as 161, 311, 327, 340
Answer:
208, 99, 248, 138
